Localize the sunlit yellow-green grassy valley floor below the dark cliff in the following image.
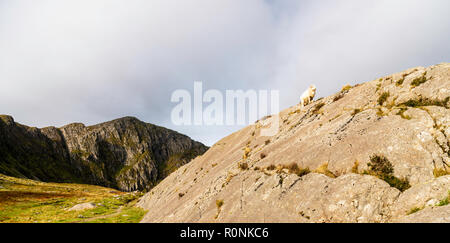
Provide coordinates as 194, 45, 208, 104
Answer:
0, 174, 146, 223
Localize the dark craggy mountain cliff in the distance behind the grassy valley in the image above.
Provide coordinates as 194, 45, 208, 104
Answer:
0, 116, 207, 191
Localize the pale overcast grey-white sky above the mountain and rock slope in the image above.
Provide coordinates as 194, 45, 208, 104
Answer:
0, 0, 450, 145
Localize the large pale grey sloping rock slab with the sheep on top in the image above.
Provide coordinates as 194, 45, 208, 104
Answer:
139, 63, 450, 222
